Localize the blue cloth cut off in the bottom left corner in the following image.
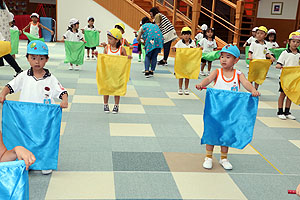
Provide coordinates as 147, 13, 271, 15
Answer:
0, 160, 29, 200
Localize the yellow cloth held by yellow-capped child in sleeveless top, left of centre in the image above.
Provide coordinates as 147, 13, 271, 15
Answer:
96, 54, 131, 96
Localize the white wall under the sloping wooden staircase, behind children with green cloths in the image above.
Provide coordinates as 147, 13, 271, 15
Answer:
57, 0, 134, 43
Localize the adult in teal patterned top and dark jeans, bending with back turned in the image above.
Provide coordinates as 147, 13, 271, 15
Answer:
137, 17, 164, 78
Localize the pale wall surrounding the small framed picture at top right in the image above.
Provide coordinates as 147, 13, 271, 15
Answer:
257, 0, 299, 20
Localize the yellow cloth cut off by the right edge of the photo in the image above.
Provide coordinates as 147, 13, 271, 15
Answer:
280, 66, 300, 105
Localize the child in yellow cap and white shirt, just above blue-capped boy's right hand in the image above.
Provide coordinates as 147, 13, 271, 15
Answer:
248, 26, 276, 89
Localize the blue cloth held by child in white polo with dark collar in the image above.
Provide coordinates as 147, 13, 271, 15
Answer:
2, 101, 62, 170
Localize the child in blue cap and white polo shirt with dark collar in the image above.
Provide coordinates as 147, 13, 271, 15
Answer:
0, 40, 68, 174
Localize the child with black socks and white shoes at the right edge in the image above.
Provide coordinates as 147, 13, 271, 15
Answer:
276, 32, 300, 120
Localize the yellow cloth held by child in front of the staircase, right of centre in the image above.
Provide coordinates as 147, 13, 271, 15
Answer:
174, 48, 202, 79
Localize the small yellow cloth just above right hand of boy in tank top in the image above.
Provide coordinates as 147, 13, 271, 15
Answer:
248, 59, 272, 85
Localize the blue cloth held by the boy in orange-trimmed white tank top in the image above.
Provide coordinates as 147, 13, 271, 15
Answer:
201, 88, 259, 149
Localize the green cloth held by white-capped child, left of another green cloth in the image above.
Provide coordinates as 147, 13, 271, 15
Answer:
65, 41, 84, 65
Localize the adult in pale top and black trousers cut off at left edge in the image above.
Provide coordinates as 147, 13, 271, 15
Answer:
0, 0, 22, 75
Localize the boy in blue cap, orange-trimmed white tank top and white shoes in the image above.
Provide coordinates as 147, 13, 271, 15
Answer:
196, 44, 260, 170
